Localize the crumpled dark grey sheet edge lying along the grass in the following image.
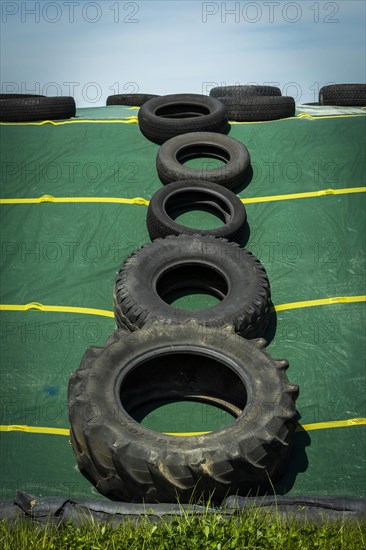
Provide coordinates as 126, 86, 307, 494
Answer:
0, 491, 366, 528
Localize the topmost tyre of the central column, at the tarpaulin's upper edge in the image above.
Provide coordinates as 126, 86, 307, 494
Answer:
138, 94, 228, 144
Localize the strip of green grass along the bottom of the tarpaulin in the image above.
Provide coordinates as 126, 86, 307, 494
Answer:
0, 510, 366, 550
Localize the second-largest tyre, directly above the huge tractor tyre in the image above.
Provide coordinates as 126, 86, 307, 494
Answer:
114, 235, 270, 338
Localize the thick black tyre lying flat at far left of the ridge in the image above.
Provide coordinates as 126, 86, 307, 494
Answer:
0, 97, 76, 122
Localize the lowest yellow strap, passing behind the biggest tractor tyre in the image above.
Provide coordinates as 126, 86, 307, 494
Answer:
0, 418, 366, 437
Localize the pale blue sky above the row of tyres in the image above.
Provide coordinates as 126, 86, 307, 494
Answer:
0, 0, 366, 107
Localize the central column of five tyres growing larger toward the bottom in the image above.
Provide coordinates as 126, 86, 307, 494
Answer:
68, 94, 298, 502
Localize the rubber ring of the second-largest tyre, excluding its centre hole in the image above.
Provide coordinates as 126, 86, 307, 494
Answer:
114, 235, 271, 339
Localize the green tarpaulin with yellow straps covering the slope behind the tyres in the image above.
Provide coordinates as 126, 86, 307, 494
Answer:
0, 107, 366, 499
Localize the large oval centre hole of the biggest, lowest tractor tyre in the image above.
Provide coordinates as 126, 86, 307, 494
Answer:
119, 352, 247, 433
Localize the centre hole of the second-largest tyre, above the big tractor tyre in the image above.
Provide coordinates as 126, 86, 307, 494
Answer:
155, 263, 228, 311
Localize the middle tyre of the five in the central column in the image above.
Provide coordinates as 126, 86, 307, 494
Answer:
146, 180, 246, 242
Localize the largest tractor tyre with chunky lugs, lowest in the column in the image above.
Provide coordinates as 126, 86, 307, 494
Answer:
68, 328, 298, 503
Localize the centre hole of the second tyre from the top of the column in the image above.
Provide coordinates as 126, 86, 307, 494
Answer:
176, 143, 231, 171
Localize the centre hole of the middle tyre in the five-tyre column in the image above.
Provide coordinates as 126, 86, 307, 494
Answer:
164, 190, 231, 230
